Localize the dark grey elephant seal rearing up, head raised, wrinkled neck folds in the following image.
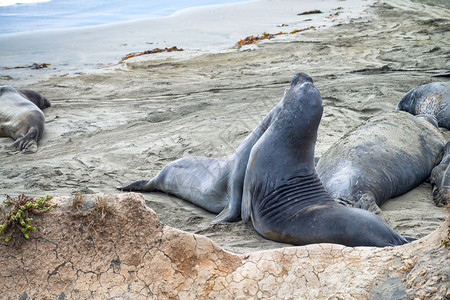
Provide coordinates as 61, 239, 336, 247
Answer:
241, 82, 409, 247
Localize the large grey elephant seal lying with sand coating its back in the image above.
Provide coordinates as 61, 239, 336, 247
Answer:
316, 111, 445, 212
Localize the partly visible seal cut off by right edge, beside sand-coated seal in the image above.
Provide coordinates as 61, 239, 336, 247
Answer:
430, 142, 450, 206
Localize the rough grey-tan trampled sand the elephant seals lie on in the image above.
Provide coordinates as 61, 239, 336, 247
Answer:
0, 0, 450, 253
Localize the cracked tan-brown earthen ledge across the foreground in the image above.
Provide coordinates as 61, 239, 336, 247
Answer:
0, 193, 450, 299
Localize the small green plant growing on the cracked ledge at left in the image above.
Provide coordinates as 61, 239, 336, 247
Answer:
0, 194, 54, 242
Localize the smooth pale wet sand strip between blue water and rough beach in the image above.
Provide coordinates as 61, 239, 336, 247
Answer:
0, 0, 373, 87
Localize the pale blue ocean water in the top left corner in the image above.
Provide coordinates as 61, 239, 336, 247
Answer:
0, 0, 250, 35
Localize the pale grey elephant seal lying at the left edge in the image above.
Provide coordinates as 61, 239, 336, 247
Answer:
0, 86, 45, 152
